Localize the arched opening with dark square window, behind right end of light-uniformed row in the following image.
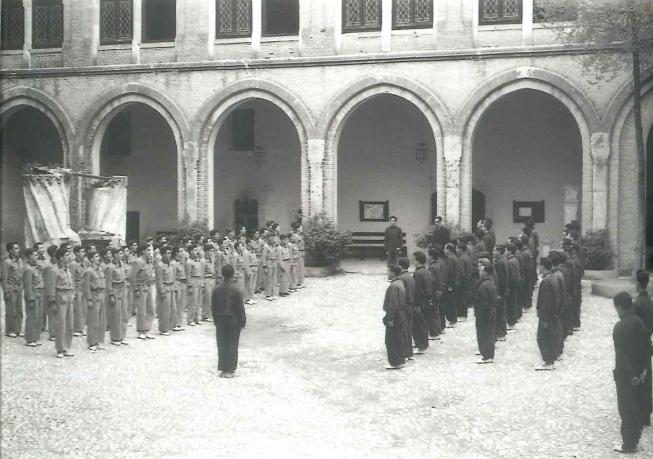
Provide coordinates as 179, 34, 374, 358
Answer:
209, 98, 301, 231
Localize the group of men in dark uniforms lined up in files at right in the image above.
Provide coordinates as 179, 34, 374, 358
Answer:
384, 219, 583, 370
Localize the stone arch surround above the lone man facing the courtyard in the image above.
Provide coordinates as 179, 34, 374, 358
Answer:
317, 75, 451, 221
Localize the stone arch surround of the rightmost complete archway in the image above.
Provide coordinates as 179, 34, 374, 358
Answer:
456, 67, 600, 234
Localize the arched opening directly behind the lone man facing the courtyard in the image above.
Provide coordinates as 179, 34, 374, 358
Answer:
336, 94, 437, 253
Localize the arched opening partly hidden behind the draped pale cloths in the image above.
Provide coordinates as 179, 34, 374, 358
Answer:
100, 102, 178, 240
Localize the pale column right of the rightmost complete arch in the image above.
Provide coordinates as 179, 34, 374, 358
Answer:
583, 132, 610, 230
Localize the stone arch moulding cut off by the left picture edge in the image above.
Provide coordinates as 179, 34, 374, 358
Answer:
0, 86, 75, 167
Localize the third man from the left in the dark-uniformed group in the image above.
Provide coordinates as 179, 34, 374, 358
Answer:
413, 251, 433, 354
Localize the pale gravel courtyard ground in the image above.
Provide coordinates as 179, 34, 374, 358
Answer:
1, 274, 653, 458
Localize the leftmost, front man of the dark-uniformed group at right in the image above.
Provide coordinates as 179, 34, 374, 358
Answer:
383, 265, 406, 370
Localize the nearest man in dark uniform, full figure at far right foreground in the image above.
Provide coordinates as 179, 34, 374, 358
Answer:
612, 292, 650, 453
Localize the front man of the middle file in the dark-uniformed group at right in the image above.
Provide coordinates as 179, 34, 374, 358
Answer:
474, 264, 497, 363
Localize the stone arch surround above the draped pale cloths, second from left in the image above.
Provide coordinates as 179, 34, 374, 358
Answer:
80, 83, 192, 225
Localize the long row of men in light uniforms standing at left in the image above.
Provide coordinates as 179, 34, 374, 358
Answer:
0, 224, 304, 358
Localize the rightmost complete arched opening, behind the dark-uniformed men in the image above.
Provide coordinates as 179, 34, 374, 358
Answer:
472, 89, 583, 247
